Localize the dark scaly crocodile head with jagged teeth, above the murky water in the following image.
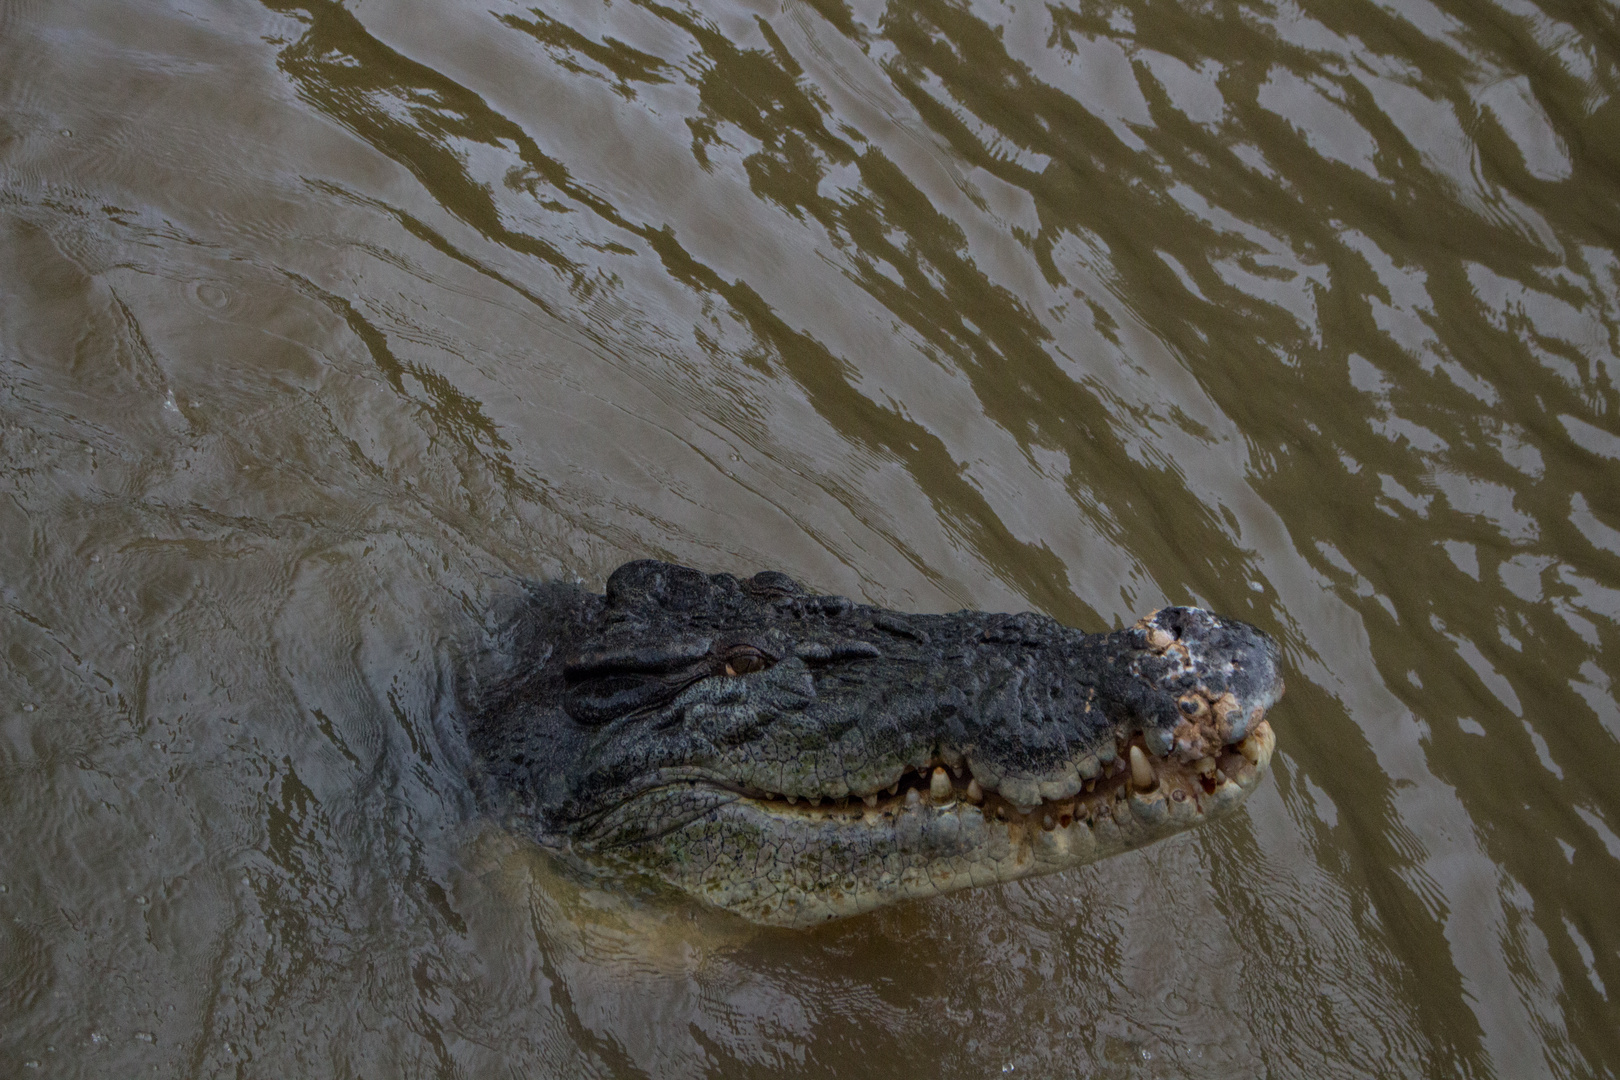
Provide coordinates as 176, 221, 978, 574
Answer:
460, 562, 1283, 926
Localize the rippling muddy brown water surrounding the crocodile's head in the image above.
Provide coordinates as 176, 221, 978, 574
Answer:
0, 0, 1620, 1078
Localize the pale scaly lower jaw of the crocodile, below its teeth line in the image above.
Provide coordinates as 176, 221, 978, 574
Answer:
602, 722, 1275, 926
